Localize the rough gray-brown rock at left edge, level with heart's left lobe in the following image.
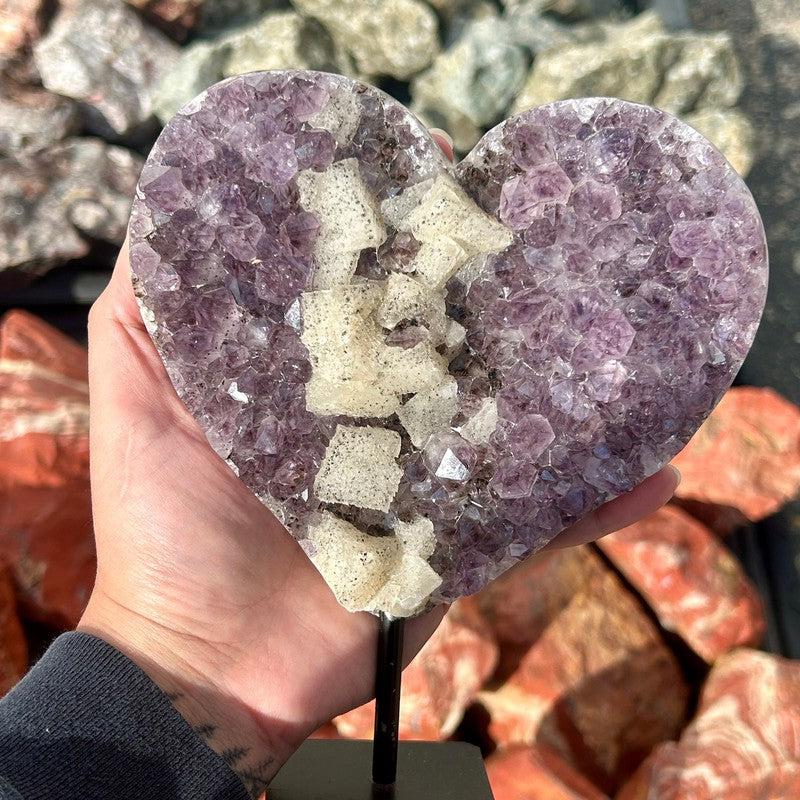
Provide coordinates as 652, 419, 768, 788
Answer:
0, 139, 142, 278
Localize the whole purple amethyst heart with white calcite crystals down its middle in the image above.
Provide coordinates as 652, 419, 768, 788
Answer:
131, 72, 767, 616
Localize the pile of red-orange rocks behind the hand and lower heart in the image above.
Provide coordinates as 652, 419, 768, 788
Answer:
0, 304, 800, 800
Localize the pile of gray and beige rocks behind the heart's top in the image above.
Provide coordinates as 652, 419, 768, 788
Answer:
0, 0, 755, 285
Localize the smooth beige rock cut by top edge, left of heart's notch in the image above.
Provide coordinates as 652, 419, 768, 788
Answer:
293, 0, 439, 80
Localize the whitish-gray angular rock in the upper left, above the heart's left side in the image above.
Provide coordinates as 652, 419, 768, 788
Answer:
34, 0, 178, 138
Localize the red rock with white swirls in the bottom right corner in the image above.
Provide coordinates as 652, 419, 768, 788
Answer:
617, 648, 800, 800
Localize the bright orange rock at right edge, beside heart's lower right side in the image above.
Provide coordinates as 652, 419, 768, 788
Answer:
674, 386, 800, 521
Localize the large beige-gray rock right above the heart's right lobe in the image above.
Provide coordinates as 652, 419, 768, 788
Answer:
513, 13, 742, 114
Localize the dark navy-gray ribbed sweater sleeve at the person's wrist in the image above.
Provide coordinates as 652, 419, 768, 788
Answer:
0, 633, 248, 800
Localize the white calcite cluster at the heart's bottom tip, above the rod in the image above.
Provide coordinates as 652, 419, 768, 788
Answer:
308, 512, 442, 617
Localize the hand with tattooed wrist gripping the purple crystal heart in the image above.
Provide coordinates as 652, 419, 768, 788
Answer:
79, 130, 677, 795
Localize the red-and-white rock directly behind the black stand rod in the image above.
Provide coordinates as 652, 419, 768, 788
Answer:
333, 598, 497, 741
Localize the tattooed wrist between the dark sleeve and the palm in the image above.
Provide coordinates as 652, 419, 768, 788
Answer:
77, 589, 306, 797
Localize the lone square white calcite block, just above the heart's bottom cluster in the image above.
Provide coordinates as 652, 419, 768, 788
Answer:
314, 425, 403, 511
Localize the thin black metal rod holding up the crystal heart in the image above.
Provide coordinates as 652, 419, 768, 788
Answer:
372, 614, 405, 786
